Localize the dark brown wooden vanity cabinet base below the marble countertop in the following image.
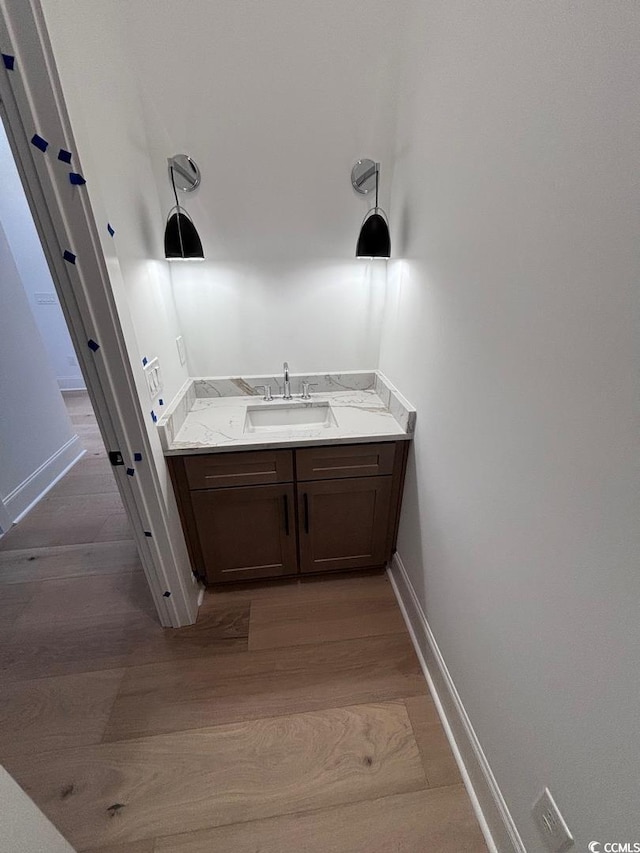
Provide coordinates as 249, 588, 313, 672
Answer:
168, 441, 408, 583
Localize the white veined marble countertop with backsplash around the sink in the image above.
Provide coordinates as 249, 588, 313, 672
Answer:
158, 371, 415, 455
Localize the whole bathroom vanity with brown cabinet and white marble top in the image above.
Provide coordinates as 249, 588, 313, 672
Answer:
158, 373, 415, 584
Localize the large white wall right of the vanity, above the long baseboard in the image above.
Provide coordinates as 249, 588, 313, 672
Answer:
381, 0, 640, 853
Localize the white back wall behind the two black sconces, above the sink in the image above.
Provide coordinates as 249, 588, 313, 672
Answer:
117, 0, 403, 375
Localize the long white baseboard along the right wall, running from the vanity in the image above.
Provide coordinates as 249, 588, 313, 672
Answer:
388, 553, 527, 853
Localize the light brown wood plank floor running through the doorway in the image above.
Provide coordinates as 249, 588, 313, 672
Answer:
0, 395, 486, 853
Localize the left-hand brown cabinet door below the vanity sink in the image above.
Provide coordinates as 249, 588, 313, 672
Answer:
191, 485, 297, 583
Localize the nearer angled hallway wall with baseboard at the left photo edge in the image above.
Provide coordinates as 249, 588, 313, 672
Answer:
0, 220, 82, 522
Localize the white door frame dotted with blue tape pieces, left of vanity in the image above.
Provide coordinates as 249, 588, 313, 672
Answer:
0, 0, 200, 627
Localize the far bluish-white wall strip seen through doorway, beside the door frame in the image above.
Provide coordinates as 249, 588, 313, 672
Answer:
0, 122, 85, 389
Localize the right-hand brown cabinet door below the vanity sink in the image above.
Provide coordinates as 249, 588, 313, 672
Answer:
298, 477, 391, 572
